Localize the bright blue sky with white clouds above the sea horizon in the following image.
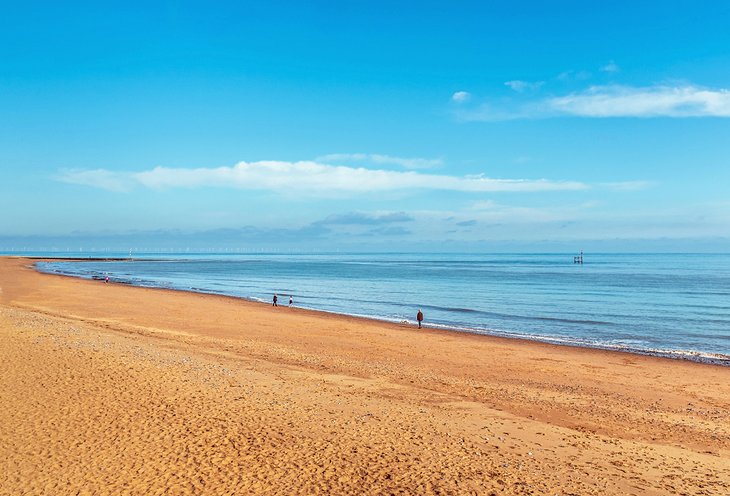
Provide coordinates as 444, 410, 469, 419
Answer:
0, 0, 730, 252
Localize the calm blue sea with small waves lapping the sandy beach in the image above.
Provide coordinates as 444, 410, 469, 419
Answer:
29, 253, 730, 365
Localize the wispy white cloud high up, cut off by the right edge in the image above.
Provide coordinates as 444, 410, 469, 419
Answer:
456, 85, 730, 121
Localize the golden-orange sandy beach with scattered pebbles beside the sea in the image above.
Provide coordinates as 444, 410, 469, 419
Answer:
0, 258, 730, 495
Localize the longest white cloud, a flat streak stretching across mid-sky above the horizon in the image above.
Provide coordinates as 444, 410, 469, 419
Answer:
60, 161, 589, 196
